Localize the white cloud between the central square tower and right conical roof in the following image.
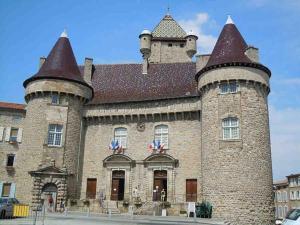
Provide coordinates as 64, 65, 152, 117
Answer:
179, 13, 217, 54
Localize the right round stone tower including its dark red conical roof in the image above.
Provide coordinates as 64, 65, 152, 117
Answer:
196, 17, 274, 225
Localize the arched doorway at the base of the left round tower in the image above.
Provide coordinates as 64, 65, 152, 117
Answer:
41, 183, 57, 212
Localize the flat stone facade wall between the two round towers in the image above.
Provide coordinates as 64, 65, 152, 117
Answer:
81, 100, 202, 207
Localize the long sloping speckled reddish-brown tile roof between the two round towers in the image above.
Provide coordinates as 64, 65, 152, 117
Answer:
79, 63, 198, 104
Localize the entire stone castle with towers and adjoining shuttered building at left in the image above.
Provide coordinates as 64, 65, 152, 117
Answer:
0, 15, 274, 225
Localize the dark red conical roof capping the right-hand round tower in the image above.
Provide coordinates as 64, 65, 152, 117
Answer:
196, 16, 271, 80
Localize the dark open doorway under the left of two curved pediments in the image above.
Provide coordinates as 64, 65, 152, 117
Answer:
110, 170, 125, 201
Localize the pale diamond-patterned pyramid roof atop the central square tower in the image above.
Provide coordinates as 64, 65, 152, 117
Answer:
152, 14, 186, 38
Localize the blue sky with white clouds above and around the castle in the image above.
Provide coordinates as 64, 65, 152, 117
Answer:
0, 0, 300, 179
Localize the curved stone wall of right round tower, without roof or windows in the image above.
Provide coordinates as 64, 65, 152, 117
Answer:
199, 68, 274, 225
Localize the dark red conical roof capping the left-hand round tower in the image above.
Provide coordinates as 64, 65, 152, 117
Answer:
23, 31, 89, 87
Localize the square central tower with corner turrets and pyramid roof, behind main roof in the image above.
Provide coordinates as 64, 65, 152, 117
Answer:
139, 14, 198, 64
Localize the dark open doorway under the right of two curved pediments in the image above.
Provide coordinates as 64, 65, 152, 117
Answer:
153, 170, 168, 201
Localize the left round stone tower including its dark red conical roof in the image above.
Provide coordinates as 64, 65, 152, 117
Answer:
17, 32, 93, 204
